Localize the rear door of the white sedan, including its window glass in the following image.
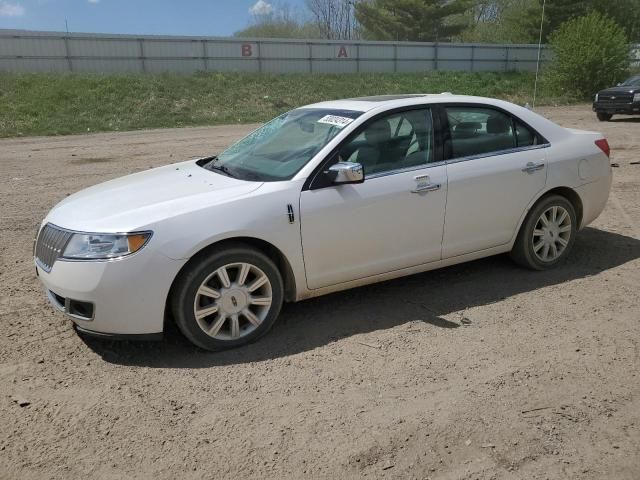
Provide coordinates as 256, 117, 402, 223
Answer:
440, 104, 548, 258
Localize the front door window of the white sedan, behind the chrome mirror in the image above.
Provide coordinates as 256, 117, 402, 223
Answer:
339, 109, 433, 176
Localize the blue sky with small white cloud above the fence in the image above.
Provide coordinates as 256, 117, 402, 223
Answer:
0, 0, 304, 36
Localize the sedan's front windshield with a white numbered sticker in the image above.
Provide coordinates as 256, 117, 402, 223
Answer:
202, 108, 362, 182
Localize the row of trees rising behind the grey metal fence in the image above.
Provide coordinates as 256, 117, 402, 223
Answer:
235, 0, 640, 43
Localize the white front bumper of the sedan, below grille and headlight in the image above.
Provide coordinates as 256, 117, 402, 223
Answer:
36, 250, 186, 336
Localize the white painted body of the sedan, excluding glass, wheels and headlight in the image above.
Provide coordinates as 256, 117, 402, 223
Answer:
36, 94, 611, 335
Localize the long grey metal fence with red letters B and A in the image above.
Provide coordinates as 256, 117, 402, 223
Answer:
0, 30, 560, 73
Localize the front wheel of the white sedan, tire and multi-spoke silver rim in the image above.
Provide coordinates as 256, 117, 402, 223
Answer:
171, 244, 284, 351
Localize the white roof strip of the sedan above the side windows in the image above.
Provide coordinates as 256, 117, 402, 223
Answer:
304, 92, 504, 112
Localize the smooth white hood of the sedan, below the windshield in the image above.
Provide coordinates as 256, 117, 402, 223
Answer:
45, 160, 262, 232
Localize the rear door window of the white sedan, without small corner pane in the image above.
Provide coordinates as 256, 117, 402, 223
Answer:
445, 107, 516, 158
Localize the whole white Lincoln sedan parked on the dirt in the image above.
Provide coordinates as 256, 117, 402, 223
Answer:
35, 94, 611, 350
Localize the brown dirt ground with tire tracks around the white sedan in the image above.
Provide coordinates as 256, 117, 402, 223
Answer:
0, 106, 640, 480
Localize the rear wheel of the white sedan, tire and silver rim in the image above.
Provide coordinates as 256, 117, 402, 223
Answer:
511, 195, 578, 270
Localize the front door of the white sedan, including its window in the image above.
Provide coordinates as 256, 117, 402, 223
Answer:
300, 108, 447, 289
